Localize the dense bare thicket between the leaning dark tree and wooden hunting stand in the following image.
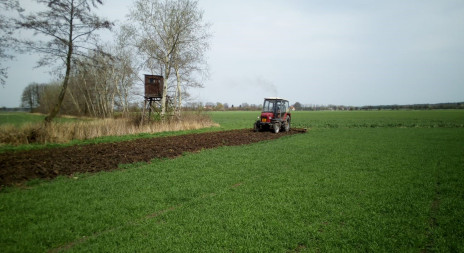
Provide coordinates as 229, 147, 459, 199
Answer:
65, 38, 137, 117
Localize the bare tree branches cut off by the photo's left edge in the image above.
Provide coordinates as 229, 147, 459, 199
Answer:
0, 0, 23, 86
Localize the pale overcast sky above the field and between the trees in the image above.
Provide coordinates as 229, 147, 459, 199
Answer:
0, 0, 464, 107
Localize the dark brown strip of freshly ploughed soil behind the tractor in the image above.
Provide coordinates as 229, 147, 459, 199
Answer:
0, 129, 306, 188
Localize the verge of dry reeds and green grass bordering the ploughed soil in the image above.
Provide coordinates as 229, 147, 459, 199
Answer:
0, 114, 218, 152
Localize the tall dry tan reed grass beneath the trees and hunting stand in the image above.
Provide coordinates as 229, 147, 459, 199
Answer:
0, 114, 219, 145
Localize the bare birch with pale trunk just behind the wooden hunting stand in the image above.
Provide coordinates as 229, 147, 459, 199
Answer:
129, 0, 208, 116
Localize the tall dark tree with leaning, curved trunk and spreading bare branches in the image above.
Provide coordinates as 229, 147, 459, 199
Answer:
19, 0, 112, 123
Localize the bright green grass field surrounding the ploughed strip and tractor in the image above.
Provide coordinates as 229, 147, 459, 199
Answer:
0, 111, 464, 252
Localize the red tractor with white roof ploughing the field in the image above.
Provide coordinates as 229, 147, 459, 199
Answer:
253, 97, 291, 133
